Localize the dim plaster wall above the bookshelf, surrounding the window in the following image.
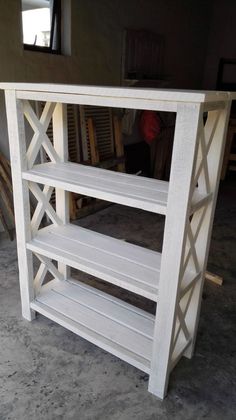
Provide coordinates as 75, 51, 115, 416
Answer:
0, 0, 208, 231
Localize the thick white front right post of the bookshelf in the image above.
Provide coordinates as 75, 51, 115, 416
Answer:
148, 104, 203, 398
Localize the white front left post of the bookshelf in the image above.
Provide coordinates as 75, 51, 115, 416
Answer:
5, 90, 35, 321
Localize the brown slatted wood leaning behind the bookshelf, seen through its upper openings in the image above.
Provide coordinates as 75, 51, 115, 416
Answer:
70, 106, 125, 220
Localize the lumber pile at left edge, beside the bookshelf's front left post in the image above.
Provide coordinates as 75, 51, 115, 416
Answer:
0, 153, 15, 240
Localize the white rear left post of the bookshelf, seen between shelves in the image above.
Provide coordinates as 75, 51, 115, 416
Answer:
53, 103, 70, 278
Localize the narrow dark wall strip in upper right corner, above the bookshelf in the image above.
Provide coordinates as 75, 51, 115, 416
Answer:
203, 0, 236, 89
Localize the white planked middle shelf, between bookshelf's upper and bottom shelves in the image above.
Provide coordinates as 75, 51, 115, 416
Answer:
27, 225, 161, 301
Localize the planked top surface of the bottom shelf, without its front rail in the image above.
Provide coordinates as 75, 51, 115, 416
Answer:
36, 280, 154, 362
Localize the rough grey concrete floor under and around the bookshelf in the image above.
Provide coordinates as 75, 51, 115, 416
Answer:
0, 176, 236, 420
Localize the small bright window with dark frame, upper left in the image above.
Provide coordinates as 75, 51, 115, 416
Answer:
21, 0, 61, 54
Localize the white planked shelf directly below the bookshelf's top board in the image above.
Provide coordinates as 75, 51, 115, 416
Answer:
23, 163, 168, 214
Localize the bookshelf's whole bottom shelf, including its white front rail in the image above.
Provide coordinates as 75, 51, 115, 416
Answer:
31, 278, 154, 373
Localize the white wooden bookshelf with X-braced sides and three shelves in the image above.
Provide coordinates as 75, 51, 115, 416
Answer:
0, 83, 235, 398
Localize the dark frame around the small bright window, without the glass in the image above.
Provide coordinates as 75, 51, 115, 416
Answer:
22, 0, 62, 54
